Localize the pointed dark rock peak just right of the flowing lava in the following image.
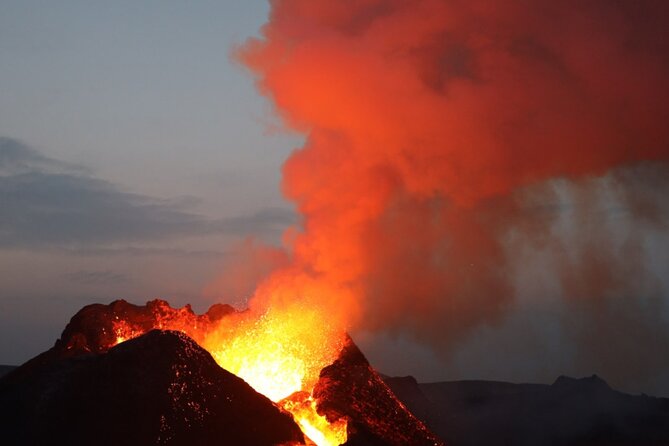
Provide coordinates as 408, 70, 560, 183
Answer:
313, 338, 443, 446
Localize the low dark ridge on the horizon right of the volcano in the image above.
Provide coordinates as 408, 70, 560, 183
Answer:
385, 376, 669, 446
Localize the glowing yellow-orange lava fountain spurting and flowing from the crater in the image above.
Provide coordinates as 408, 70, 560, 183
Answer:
112, 304, 347, 446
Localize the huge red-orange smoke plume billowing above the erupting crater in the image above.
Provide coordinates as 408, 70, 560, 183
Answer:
231, 0, 669, 368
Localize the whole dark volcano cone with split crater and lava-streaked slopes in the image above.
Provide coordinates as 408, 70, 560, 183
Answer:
0, 300, 443, 446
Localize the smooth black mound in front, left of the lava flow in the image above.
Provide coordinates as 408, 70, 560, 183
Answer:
0, 330, 303, 445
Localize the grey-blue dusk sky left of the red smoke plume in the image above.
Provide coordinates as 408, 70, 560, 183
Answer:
0, 1, 302, 358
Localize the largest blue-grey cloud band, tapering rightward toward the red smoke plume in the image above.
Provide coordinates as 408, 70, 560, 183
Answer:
0, 138, 293, 248
